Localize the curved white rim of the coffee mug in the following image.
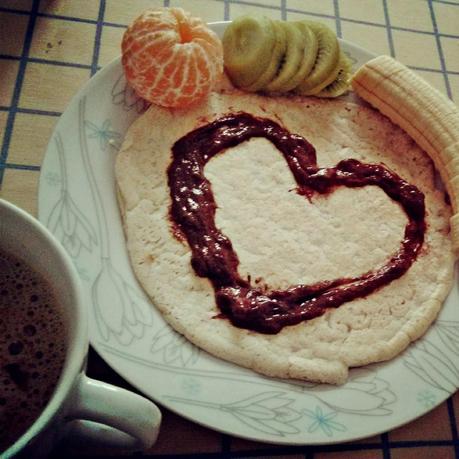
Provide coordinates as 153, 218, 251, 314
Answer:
0, 198, 89, 459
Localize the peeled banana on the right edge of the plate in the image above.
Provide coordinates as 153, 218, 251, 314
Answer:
351, 56, 459, 258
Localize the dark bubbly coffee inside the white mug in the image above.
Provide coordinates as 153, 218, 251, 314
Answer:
0, 251, 66, 453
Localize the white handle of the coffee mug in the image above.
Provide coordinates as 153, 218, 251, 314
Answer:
64, 374, 161, 450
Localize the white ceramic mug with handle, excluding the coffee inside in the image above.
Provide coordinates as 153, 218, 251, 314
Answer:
0, 199, 161, 459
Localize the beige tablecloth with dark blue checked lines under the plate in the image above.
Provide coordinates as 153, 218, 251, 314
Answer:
0, 0, 459, 459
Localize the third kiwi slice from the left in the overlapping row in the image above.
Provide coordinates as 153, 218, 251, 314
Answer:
264, 21, 304, 92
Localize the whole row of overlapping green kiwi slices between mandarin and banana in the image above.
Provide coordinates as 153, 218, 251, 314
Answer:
223, 16, 351, 97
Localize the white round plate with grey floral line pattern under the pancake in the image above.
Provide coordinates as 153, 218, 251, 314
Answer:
39, 23, 459, 444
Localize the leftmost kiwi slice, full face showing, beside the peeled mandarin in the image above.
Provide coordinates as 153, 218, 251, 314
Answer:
222, 16, 275, 87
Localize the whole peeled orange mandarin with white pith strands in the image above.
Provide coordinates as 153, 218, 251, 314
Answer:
121, 8, 223, 107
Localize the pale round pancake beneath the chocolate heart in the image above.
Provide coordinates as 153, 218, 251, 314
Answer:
116, 91, 454, 384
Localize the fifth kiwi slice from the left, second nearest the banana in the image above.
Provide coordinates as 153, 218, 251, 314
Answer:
295, 20, 340, 96
